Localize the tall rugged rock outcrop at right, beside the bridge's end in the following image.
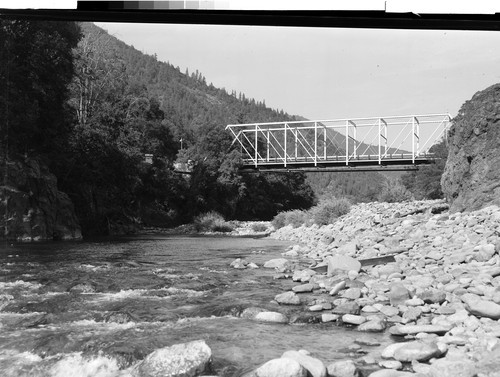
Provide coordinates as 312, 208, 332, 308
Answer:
441, 84, 500, 212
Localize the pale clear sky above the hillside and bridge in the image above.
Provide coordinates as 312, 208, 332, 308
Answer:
97, 23, 500, 120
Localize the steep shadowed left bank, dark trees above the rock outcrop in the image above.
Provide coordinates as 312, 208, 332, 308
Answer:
0, 19, 81, 240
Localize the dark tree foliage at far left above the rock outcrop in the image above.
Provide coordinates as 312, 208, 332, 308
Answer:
0, 19, 80, 161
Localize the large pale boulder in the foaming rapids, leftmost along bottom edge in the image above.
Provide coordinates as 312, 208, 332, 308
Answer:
132, 340, 212, 377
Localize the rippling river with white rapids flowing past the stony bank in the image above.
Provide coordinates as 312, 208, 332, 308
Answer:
0, 235, 389, 377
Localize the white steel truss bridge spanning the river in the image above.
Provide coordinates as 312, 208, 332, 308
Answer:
226, 114, 451, 171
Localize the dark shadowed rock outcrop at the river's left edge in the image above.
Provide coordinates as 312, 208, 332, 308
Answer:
0, 159, 82, 242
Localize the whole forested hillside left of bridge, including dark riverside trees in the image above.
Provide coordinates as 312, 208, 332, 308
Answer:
0, 20, 314, 235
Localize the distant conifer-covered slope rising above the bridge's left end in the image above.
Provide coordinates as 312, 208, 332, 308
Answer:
86, 23, 295, 146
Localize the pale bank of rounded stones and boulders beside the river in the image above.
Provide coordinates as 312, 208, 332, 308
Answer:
233, 201, 500, 377
